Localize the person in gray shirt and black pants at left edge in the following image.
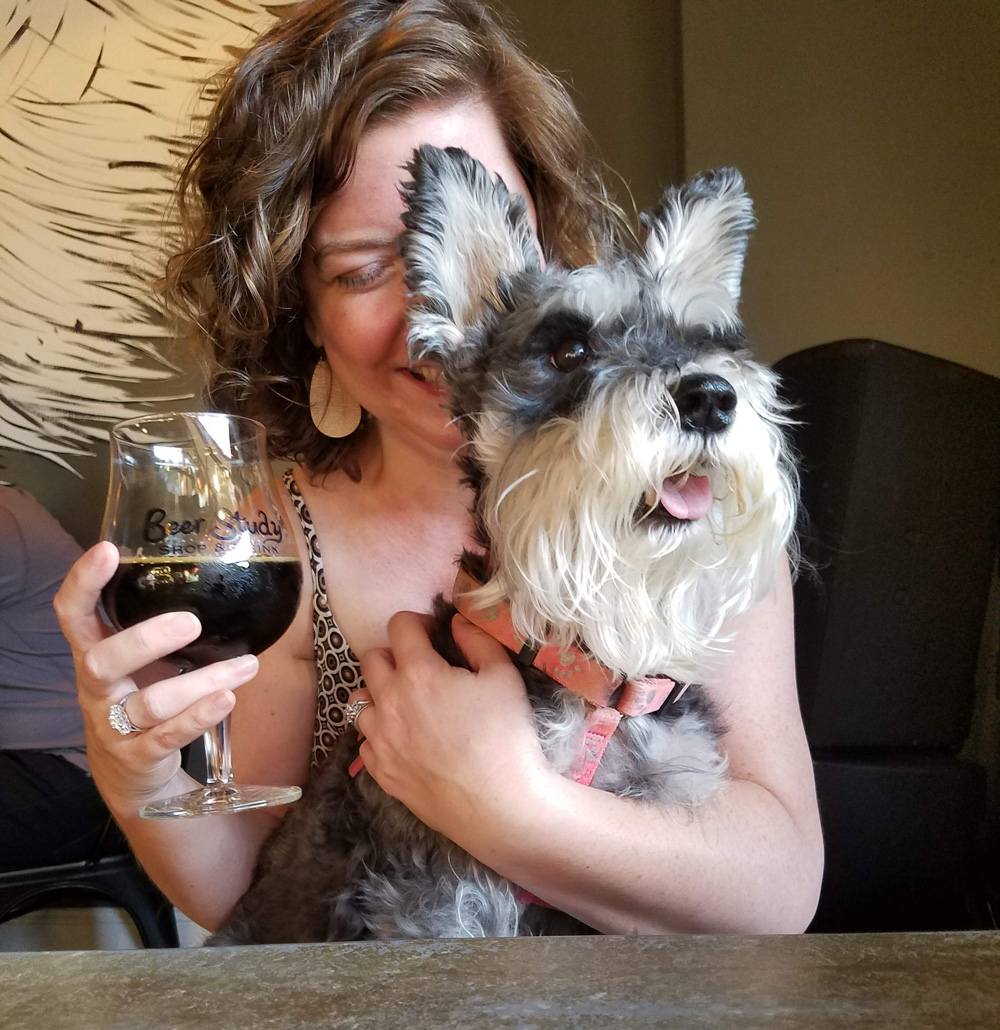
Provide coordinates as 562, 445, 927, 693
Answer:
0, 486, 128, 871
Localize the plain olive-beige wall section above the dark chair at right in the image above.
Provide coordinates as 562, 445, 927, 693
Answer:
682, 0, 1000, 375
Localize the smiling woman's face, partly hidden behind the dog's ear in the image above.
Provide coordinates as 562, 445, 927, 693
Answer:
302, 101, 535, 463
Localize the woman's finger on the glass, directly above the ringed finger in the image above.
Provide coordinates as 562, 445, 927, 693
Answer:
77, 612, 201, 697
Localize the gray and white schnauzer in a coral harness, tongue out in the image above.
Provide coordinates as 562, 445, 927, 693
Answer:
209, 146, 796, 945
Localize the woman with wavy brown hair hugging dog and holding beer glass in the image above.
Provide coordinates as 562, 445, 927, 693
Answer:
52, 0, 822, 934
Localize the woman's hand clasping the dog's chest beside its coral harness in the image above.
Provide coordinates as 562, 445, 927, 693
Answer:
351, 612, 550, 839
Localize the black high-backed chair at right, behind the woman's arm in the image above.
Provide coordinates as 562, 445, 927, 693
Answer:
774, 340, 1000, 933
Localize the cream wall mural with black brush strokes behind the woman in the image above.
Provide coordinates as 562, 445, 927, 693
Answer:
0, 0, 283, 470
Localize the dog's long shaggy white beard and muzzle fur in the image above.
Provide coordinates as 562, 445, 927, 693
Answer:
473, 357, 795, 682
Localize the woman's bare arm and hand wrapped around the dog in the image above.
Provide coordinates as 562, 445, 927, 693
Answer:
359, 570, 823, 934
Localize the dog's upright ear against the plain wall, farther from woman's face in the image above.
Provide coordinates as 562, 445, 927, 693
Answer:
641, 168, 754, 328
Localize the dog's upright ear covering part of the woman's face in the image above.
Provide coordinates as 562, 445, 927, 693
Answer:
401, 145, 539, 366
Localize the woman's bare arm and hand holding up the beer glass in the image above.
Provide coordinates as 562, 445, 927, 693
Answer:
56, 494, 316, 929
